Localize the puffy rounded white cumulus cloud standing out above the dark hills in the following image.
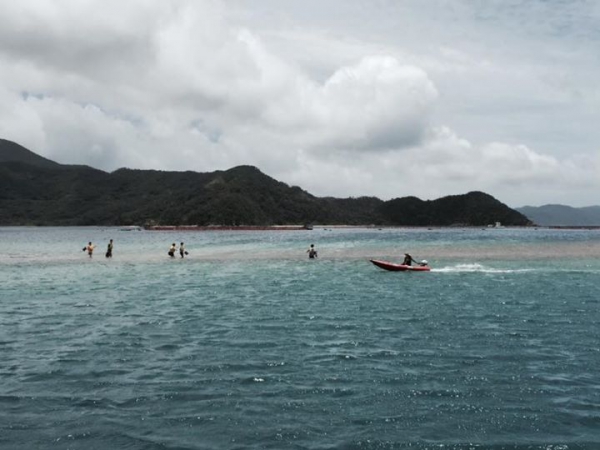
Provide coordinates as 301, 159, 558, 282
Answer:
256, 56, 437, 151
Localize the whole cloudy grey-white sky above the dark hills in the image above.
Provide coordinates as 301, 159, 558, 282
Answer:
0, 0, 600, 207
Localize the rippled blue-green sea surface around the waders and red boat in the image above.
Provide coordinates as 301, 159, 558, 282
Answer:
0, 227, 600, 450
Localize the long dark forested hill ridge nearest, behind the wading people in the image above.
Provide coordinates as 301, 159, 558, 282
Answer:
0, 140, 531, 226
